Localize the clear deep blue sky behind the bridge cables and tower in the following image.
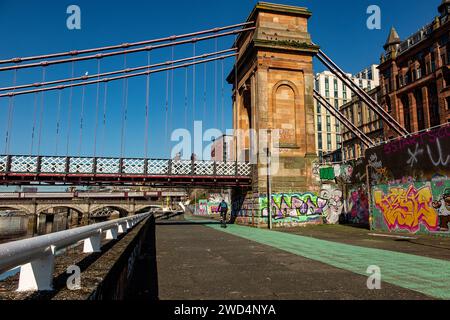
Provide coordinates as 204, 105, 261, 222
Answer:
0, 0, 441, 158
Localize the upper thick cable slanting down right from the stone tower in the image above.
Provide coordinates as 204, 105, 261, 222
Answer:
317, 50, 409, 136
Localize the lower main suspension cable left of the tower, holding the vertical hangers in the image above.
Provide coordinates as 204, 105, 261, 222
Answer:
0, 53, 237, 98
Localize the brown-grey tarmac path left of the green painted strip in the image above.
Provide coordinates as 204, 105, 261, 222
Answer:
156, 215, 432, 300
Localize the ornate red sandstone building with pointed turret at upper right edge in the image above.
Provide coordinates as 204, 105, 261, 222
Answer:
378, 0, 450, 139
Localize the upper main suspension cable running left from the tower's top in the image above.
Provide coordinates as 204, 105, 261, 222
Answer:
0, 21, 254, 64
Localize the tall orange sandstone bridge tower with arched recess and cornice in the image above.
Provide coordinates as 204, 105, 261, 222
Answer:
227, 2, 319, 225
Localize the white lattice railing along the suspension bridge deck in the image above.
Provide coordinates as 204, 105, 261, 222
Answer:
0, 155, 251, 183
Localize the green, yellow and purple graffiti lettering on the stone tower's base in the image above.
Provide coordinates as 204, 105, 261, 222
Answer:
259, 193, 327, 222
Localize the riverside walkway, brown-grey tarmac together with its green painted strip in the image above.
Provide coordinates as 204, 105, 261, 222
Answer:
156, 215, 442, 300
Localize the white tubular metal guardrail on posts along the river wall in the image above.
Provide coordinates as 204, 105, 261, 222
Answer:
0, 213, 150, 292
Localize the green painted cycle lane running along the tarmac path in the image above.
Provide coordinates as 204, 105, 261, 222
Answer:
192, 220, 450, 299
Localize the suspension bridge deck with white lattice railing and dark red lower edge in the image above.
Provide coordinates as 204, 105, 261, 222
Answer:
0, 155, 251, 187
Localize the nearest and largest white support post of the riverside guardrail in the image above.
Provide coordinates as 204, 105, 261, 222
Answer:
17, 246, 55, 292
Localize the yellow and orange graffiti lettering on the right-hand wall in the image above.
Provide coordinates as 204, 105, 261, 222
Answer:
374, 186, 439, 233
